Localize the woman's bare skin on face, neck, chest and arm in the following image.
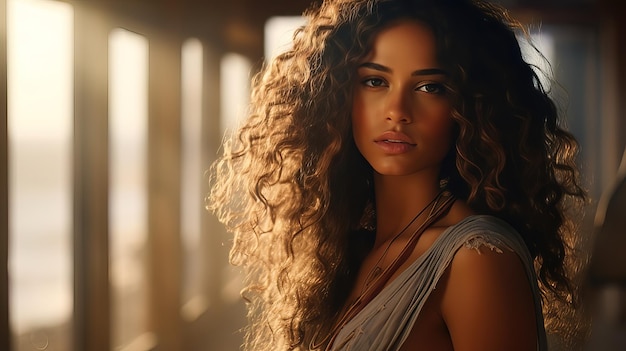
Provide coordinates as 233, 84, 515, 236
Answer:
349, 20, 537, 351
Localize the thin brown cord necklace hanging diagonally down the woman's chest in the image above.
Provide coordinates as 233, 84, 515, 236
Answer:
310, 189, 455, 350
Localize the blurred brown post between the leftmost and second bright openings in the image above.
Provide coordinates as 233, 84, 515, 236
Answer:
73, 1, 111, 351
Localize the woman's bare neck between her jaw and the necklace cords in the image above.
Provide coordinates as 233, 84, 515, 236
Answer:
374, 174, 440, 245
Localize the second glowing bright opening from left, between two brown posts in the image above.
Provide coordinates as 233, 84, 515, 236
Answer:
109, 29, 148, 347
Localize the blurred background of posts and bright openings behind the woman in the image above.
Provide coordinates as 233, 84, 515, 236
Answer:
0, 0, 626, 351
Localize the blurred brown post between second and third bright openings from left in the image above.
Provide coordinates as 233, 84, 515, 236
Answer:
148, 31, 182, 350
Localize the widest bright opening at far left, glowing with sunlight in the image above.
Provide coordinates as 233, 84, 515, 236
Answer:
7, 0, 74, 336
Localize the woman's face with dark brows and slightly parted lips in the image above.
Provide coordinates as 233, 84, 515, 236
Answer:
352, 20, 453, 176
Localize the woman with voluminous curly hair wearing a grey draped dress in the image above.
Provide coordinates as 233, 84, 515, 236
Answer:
209, 0, 585, 350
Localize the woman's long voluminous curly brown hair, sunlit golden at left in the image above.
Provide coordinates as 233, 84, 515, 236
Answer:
207, 0, 586, 350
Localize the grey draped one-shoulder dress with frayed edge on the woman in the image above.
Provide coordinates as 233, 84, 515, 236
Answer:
331, 215, 547, 351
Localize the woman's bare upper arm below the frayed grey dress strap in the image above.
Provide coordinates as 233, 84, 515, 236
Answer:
441, 246, 537, 351
